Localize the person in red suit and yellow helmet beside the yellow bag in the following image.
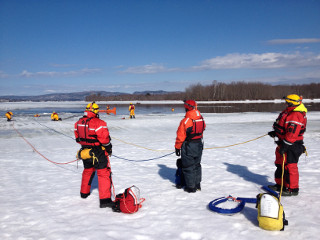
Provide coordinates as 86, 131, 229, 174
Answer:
268, 94, 308, 196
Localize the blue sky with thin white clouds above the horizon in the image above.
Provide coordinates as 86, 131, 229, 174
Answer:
0, 0, 320, 95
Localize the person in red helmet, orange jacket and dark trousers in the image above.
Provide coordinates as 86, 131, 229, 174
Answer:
175, 100, 206, 193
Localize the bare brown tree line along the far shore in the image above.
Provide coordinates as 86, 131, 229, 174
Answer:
86, 81, 320, 101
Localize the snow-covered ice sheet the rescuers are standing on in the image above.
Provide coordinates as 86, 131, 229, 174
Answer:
0, 103, 320, 240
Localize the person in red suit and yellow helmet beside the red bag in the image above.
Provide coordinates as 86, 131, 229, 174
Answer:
74, 102, 113, 208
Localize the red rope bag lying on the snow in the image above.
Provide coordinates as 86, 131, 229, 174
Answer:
112, 185, 145, 213
